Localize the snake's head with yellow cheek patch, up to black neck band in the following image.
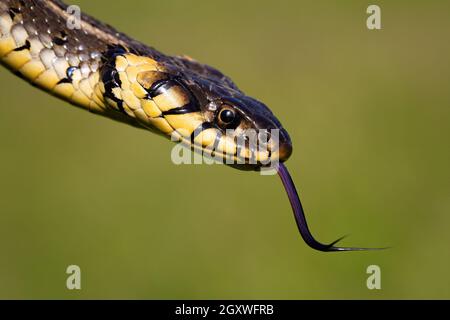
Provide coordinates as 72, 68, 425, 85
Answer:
108, 51, 292, 170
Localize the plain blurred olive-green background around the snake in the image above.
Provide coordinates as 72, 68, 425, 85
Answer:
0, 0, 450, 299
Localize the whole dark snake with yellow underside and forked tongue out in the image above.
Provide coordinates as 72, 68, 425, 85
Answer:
0, 0, 382, 252
